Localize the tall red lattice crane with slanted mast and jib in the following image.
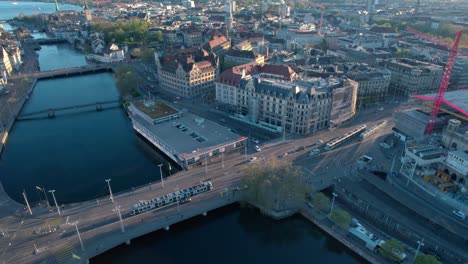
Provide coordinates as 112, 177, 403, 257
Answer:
407, 28, 462, 135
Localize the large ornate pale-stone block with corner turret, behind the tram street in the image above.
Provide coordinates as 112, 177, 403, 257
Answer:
216, 64, 357, 135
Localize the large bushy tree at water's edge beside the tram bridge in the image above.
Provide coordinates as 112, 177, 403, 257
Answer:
242, 158, 312, 210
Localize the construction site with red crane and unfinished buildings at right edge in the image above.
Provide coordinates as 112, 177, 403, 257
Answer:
393, 30, 468, 213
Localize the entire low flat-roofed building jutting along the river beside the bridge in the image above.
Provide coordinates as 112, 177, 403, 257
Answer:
128, 99, 247, 169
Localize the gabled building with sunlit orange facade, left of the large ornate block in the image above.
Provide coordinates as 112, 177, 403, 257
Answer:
154, 50, 218, 98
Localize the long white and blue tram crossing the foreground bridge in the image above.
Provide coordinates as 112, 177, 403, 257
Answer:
130, 181, 213, 216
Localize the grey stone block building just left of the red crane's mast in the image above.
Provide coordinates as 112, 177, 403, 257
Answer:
386, 59, 443, 96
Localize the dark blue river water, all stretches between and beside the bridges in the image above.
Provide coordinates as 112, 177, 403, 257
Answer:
0, 2, 363, 264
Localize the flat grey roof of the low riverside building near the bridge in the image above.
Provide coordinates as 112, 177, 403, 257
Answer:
132, 112, 240, 158
